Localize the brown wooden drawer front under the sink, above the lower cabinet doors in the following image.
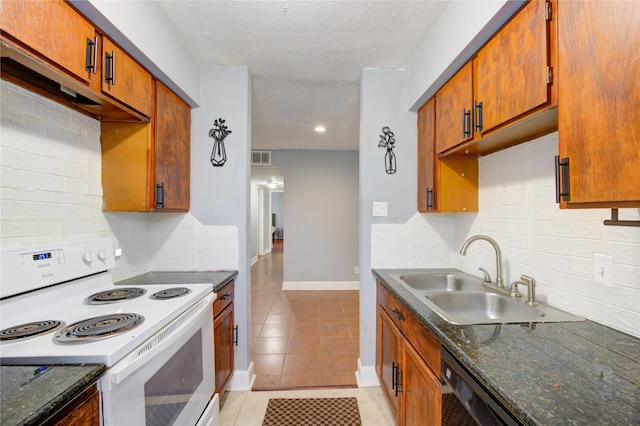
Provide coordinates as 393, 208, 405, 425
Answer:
377, 281, 440, 378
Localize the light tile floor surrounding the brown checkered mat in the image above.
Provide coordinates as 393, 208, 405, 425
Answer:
220, 387, 395, 426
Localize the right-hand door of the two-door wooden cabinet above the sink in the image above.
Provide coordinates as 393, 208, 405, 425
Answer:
474, 0, 550, 132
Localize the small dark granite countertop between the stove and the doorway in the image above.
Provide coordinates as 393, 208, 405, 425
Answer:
115, 271, 238, 293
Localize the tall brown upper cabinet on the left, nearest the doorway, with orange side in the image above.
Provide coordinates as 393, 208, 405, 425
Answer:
101, 81, 191, 212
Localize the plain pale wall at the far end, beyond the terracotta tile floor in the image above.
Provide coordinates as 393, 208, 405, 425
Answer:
271, 150, 358, 288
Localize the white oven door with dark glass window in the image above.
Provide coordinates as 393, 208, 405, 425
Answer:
101, 294, 217, 426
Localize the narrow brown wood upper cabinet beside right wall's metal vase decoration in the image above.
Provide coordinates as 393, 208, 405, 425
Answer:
418, 97, 478, 213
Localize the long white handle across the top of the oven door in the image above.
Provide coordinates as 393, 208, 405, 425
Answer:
109, 293, 215, 390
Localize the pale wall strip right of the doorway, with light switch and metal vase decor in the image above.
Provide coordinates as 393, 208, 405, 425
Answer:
358, 69, 418, 385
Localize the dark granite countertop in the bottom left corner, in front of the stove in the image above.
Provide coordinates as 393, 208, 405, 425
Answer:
0, 364, 106, 426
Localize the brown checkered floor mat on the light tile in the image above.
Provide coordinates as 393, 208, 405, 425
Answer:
262, 398, 362, 426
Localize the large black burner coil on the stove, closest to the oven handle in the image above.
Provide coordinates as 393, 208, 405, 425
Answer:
56, 314, 144, 342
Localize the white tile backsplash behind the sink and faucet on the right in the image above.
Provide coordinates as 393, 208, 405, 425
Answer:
371, 133, 640, 337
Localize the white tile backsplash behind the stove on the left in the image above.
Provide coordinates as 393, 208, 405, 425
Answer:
0, 80, 239, 280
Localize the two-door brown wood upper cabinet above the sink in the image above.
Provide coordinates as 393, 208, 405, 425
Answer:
436, 0, 557, 157
